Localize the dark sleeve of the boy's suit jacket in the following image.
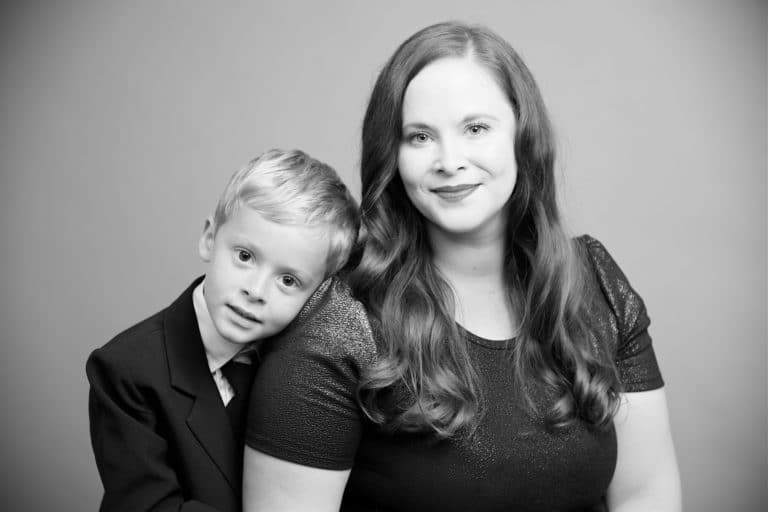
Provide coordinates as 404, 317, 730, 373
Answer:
85, 349, 222, 512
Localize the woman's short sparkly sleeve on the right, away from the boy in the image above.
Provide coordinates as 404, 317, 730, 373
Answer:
580, 235, 664, 392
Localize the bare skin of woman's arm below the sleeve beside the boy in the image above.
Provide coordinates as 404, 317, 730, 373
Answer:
243, 446, 350, 512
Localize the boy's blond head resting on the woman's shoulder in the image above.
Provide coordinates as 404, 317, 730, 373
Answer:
199, 149, 359, 344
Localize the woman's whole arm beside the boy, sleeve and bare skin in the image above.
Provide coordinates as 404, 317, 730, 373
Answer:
243, 281, 376, 512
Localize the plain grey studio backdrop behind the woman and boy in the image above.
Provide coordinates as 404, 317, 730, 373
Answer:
0, 0, 768, 512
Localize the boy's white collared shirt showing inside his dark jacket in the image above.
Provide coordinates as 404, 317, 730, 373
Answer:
192, 279, 253, 406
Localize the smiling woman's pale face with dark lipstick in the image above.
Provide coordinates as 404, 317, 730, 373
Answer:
398, 57, 517, 241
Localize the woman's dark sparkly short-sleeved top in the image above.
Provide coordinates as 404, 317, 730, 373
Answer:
246, 237, 663, 512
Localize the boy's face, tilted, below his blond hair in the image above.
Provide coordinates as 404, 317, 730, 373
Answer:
199, 206, 329, 344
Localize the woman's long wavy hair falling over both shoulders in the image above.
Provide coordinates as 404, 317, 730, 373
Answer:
349, 22, 620, 437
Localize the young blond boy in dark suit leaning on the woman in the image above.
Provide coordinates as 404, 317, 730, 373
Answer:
86, 150, 359, 512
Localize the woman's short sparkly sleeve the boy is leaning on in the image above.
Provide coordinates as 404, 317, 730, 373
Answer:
246, 279, 375, 469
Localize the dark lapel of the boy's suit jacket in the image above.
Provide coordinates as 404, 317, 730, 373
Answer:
160, 277, 240, 492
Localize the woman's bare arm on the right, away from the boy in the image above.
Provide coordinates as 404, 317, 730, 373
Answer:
608, 388, 682, 512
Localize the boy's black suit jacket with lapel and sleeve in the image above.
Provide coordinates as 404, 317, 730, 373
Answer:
86, 278, 250, 512
